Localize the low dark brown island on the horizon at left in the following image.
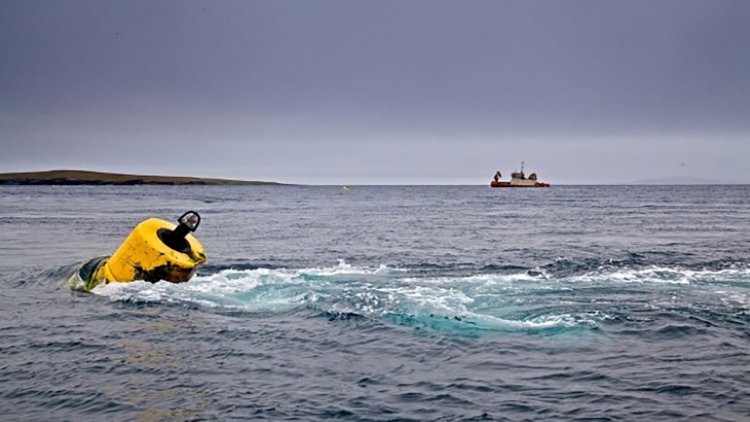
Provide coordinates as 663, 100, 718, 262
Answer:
0, 170, 281, 186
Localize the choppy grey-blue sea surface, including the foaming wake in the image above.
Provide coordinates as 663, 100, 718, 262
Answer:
0, 186, 750, 421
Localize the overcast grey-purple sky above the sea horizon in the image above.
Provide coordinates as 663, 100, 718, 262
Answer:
0, 0, 750, 184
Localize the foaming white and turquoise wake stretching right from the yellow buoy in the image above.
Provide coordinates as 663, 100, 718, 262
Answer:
89, 260, 750, 331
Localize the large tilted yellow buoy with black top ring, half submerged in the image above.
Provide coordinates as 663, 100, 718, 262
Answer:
70, 211, 206, 291
